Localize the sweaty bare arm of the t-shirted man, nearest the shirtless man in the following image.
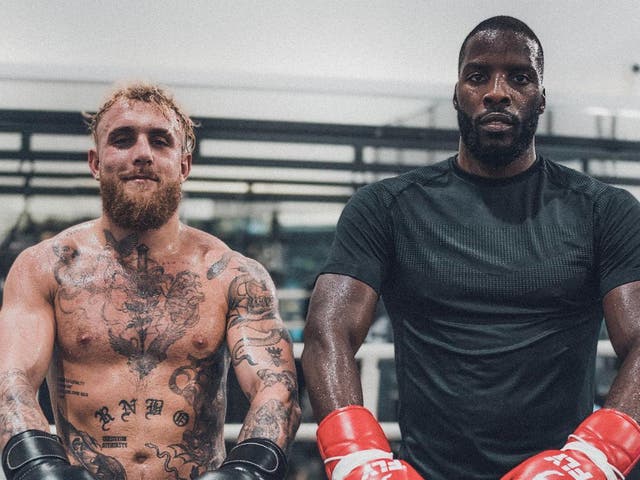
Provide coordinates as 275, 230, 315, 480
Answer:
302, 274, 378, 421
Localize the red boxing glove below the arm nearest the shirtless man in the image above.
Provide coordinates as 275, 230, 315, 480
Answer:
318, 405, 423, 480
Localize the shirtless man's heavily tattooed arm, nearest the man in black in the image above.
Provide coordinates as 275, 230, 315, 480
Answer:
227, 259, 300, 451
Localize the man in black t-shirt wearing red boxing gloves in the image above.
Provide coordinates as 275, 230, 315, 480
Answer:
302, 16, 640, 480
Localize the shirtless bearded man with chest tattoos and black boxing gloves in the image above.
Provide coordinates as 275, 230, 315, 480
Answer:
0, 84, 300, 480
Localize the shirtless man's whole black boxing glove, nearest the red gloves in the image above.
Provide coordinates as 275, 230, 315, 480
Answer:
197, 438, 287, 480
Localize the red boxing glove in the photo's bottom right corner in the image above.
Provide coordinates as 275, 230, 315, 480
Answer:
501, 409, 640, 480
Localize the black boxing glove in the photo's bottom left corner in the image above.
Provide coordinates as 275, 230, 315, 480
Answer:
2, 430, 95, 480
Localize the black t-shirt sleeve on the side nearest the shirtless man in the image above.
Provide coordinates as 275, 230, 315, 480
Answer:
320, 185, 393, 293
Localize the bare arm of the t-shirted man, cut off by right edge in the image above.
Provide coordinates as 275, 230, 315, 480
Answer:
603, 282, 640, 421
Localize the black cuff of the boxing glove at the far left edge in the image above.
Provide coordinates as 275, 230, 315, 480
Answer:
2, 430, 69, 478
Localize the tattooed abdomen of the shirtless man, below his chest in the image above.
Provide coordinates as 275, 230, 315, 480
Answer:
48, 356, 225, 480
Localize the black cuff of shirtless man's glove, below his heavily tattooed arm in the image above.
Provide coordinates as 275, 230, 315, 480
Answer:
221, 438, 287, 480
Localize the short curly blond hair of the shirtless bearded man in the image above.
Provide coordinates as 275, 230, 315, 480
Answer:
84, 82, 196, 153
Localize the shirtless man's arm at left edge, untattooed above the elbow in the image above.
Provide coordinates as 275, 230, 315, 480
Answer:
0, 249, 55, 448
